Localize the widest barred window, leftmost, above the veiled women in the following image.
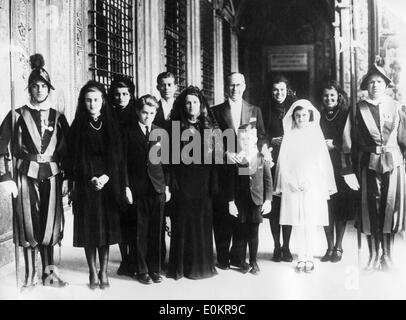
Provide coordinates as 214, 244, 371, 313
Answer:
89, 0, 135, 86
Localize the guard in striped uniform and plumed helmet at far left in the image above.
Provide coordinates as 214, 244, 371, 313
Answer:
0, 54, 68, 287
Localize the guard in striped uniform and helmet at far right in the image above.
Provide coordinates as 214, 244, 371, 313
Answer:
343, 65, 406, 270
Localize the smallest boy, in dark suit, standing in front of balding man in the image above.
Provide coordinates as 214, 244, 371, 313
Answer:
229, 124, 273, 275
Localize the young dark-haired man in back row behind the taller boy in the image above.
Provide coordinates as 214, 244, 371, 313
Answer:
154, 72, 178, 267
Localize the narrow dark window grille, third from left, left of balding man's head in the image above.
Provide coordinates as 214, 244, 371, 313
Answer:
200, 0, 214, 104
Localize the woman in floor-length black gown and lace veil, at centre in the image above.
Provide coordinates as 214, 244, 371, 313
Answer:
168, 87, 217, 279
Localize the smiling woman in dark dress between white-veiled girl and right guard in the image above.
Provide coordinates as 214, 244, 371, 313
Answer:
320, 80, 354, 262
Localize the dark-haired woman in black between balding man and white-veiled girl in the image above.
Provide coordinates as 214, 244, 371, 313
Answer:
262, 74, 297, 262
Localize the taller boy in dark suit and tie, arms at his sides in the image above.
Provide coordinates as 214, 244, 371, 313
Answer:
126, 95, 171, 284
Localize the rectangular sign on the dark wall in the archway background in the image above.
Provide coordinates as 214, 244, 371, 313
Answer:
268, 52, 309, 71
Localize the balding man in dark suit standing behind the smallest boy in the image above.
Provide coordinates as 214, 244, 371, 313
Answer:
212, 73, 266, 272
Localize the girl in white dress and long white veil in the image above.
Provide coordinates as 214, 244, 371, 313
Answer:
275, 100, 337, 272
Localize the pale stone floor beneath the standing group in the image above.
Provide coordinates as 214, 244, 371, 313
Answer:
0, 213, 406, 300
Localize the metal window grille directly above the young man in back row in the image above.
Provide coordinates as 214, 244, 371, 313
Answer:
165, 0, 187, 90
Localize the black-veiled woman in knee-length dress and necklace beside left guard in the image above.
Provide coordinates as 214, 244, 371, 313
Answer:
68, 81, 124, 289
